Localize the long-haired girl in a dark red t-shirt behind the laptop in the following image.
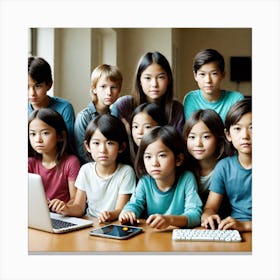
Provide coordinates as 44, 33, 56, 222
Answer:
28, 108, 80, 210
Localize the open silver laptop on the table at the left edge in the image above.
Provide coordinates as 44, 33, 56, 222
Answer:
28, 173, 93, 233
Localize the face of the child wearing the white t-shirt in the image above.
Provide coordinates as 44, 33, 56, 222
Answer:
85, 129, 121, 166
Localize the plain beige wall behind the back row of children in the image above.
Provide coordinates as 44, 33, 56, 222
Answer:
30, 28, 252, 114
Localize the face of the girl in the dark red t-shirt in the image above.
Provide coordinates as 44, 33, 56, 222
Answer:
29, 119, 61, 158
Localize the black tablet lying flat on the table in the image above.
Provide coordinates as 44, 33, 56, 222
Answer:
89, 224, 143, 239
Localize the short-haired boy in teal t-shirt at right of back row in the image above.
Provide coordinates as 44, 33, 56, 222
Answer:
183, 49, 244, 121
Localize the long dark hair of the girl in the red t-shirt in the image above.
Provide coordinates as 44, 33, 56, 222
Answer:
28, 108, 70, 165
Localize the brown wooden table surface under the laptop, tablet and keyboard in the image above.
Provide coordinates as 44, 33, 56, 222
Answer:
28, 219, 252, 254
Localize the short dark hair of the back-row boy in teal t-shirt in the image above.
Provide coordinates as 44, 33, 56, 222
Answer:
193, 49, 225, 73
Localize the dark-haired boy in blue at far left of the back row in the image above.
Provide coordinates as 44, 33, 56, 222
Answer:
28, 57, 75, 146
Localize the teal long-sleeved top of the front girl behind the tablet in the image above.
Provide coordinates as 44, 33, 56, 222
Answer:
122, 171, 202, 227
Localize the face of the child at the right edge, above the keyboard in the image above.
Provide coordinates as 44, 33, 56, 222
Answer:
226, 113, 252, 155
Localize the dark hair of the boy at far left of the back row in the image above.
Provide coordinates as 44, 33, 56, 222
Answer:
28, 56, 53, 84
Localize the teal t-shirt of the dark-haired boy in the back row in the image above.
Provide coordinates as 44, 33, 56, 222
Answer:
183, 89, 244, 121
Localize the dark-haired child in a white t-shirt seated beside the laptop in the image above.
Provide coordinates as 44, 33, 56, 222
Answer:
54, 114, 136, 222
